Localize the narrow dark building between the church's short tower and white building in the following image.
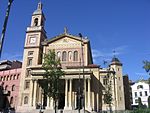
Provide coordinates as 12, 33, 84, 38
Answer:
123, 75, 132, 110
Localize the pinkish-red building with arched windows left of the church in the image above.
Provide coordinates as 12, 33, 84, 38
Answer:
0, 60, 22, 109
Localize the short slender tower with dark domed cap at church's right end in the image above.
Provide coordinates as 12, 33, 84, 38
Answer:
110, 56, 125, 110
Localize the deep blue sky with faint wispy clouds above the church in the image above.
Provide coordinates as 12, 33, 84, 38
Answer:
0, 0, 150, 81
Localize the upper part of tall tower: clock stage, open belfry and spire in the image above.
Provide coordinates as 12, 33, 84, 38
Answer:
25, 2, 46, 48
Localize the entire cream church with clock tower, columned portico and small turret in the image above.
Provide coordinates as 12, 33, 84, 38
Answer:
17, 3, 125, 113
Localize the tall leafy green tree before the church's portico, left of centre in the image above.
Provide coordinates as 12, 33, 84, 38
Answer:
42, 50, 64, 113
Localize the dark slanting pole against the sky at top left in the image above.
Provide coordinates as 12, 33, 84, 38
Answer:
0, 0, 14, 57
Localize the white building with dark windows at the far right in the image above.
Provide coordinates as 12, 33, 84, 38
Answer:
131, 80, 150, 107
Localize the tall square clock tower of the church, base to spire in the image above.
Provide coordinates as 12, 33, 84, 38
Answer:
18, 2, 47, 109
